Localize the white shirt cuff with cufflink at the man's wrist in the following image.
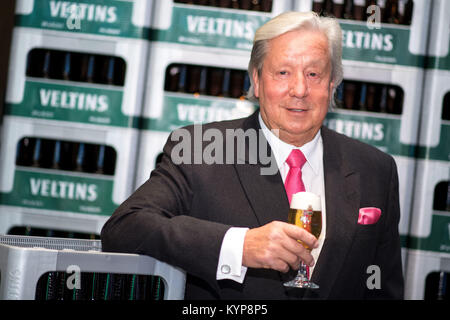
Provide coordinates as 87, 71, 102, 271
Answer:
216, 228, 249, 283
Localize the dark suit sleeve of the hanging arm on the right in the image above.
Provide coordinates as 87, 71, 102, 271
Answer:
368, 158, 404, 299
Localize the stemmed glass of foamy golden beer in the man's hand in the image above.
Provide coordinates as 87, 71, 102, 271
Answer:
284, 192, 322, 289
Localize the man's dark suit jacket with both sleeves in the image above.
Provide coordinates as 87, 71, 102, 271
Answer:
101, 112, 403, 299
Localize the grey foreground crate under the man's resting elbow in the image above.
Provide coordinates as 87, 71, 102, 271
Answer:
0, 236, 186, 300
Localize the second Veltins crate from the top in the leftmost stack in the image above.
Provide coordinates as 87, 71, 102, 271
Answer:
5, 27, 148, 130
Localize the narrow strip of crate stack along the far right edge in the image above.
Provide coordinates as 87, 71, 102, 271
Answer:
405, 0, 450, 300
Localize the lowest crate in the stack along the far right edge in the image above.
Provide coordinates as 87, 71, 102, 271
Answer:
405, 250, 450, 300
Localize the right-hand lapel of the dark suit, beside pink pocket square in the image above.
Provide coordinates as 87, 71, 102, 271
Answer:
305, 127, 360, 299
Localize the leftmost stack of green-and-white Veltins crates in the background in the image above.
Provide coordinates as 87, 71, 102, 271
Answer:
0, 0, 153, 238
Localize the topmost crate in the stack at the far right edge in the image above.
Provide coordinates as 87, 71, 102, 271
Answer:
426, 0, 450, 73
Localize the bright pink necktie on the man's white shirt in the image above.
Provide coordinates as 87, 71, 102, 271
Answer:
284, 149, 306, 203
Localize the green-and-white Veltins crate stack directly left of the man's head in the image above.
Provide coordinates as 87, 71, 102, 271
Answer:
136, 0, 292, 186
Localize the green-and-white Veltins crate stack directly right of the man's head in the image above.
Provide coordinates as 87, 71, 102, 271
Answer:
296, 0, 431, 271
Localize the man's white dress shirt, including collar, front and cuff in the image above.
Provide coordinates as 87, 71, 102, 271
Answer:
216, 114, 326, 283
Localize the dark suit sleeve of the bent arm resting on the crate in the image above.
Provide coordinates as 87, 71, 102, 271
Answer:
101, 129, 230, 286
